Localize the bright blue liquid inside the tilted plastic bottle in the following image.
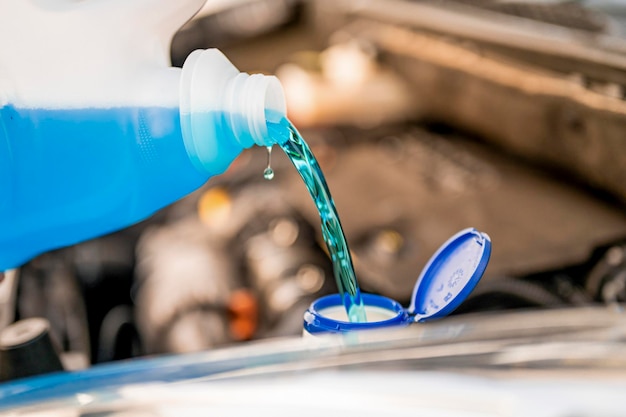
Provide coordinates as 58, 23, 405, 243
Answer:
0, 106, 242, 270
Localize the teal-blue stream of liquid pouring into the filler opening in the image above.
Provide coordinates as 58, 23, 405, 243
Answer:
268, 118, 367, 322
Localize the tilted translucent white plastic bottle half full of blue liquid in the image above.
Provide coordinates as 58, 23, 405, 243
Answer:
0, 0, 285, 271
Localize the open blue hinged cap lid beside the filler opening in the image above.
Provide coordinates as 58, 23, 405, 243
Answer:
408, 228, 491, 321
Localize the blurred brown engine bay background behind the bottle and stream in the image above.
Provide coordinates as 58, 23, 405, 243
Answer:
0, 0, 626, 369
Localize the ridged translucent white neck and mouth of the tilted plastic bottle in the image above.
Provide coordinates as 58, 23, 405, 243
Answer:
179, 49, 286, 173
